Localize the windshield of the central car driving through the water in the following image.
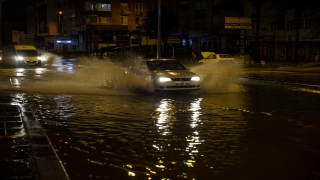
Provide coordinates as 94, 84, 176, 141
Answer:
147, 60, 186, 70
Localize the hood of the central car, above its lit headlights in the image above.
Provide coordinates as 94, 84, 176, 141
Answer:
151, 70, 198, 78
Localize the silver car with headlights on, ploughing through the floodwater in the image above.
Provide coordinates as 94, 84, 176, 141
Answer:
127, 58, 200, 91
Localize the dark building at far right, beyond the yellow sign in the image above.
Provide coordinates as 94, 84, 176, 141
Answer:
244, 0, 320, 61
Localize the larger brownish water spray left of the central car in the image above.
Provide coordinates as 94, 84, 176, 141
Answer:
21, 56, 153, 95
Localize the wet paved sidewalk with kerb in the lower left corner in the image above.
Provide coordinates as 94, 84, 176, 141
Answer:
0, 90, 69, 180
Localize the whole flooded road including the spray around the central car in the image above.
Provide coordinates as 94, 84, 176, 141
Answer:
1, 55, 320, 180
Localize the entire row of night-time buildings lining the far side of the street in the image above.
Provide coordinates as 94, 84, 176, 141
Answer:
21, 0, 320, 61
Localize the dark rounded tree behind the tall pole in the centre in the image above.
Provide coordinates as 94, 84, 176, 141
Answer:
142, 7, 178, 43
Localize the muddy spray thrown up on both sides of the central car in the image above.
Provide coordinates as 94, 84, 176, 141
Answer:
15, 53, 243, 94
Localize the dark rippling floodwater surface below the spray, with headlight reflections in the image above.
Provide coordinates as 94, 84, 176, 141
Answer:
17, 82, 320, 180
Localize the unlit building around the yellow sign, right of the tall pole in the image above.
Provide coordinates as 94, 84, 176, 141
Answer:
153, 0, 243, 56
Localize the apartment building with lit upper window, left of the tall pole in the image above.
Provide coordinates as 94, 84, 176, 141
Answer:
72, 0, 149, 52
